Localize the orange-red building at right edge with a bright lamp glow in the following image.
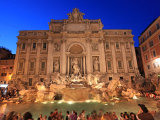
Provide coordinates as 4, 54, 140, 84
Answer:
139, 16, 160, 77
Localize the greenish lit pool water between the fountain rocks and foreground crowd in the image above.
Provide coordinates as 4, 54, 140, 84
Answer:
1, 98, 157, 119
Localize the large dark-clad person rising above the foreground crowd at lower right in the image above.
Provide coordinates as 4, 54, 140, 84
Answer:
137, 104, 154, 120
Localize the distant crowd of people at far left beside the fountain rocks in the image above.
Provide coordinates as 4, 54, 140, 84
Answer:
0, 88, 19, 102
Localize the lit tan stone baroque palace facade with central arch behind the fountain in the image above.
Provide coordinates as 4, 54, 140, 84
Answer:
12, 8, 138, 86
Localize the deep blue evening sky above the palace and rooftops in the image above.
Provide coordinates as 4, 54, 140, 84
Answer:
0, 0, 160, 53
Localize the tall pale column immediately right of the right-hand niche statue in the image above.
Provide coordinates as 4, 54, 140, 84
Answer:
99, 40, 106, 73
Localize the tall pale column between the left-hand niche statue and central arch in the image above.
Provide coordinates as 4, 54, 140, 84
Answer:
60, 40, 66, 74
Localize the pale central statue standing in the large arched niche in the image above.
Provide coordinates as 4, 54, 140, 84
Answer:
72, 58, 80, 75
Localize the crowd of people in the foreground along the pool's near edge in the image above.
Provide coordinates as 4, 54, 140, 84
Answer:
2, 104, 154, 120
